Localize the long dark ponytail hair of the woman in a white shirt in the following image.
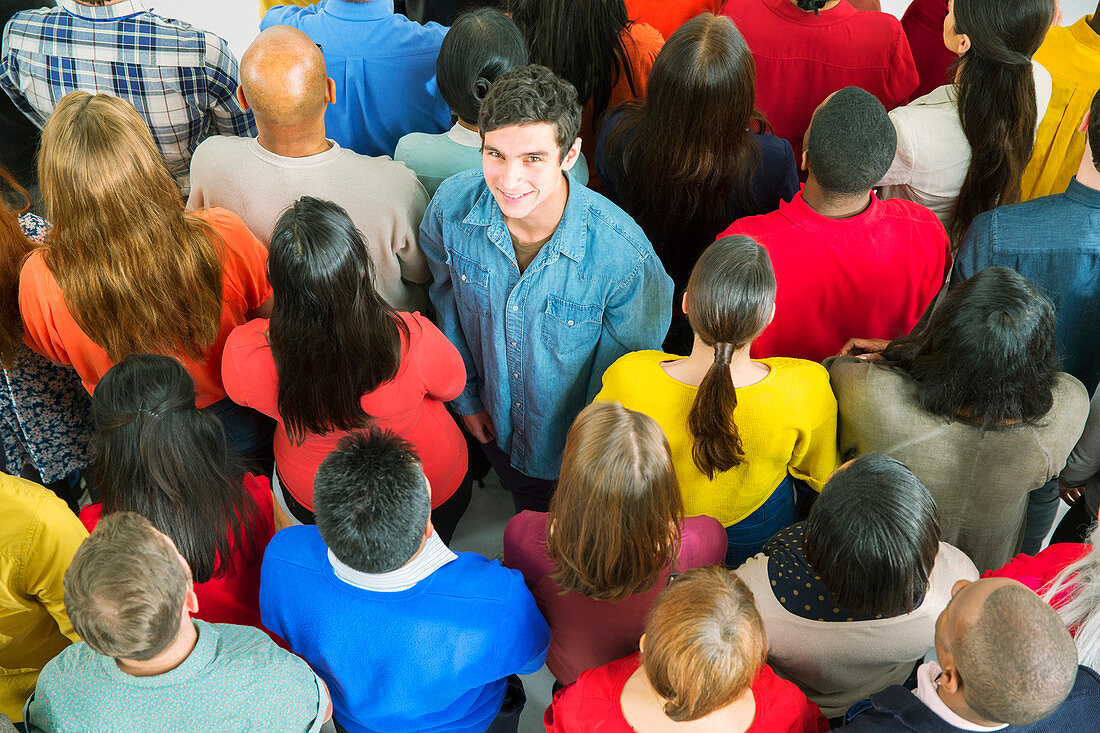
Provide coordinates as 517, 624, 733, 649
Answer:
948, 0, 1054, 239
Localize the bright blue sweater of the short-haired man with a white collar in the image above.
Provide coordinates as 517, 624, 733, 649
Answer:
260, 526, 550, 733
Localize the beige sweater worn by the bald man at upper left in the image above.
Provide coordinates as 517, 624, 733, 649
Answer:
187, 135, 429, 311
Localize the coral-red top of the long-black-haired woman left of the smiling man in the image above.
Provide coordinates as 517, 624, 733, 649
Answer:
221, 313, 466, 510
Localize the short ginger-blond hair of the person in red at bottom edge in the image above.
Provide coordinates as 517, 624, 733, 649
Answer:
641, 567, 768, 723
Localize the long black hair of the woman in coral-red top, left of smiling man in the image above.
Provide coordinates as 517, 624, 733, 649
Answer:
267, 196, 409, 445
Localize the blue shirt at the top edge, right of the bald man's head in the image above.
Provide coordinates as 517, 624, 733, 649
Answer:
260, 0, 451, 156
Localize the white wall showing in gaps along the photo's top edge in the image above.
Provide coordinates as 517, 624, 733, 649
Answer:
157, 0, 1096, 58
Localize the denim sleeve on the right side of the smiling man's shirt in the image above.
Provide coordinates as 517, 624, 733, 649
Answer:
585, 251, 673, 404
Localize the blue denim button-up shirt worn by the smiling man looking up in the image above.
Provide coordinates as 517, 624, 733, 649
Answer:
420, 171, 672, 479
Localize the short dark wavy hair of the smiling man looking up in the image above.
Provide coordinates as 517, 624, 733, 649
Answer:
477, 64, 581, 157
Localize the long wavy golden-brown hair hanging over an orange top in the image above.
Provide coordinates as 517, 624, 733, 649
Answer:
39, 91, 224, 362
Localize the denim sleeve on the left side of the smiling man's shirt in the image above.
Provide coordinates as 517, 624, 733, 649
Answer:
420, 197, 485, 415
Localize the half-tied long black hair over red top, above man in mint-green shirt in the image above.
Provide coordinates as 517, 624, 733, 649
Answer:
91, 353, 261, 583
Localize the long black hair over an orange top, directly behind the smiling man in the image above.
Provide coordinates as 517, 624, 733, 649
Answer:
509, 0, 638, 124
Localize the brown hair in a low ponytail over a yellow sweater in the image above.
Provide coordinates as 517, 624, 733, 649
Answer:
686, 236, 776, 479
